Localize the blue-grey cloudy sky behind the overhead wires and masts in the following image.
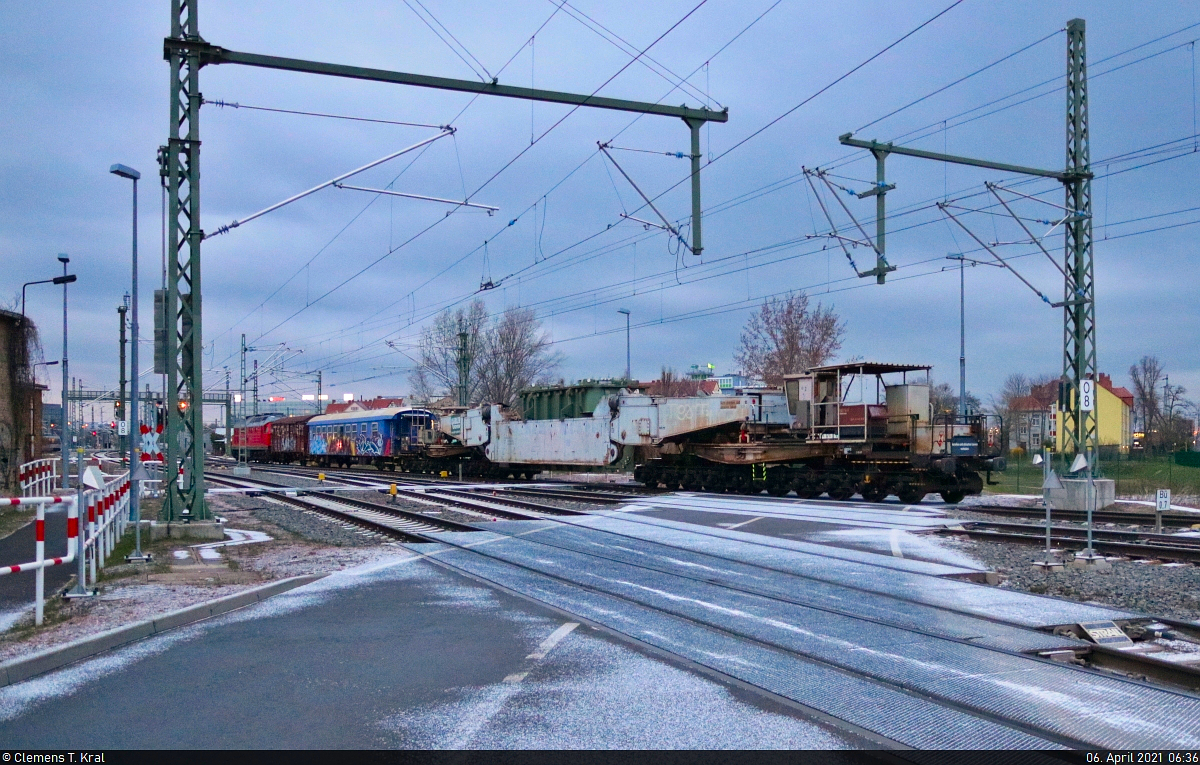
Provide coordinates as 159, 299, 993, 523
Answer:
0, 0, 1200, 422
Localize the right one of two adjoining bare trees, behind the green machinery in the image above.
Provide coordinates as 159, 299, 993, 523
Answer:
479, 308, 563, 406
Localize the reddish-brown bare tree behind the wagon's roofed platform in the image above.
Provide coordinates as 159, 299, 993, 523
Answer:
733, 293, 846, 385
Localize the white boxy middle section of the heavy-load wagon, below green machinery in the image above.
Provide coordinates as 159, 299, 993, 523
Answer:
484, 399, 619, 466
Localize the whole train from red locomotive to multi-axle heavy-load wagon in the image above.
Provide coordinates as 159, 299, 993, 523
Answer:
234, 362, 1004, 502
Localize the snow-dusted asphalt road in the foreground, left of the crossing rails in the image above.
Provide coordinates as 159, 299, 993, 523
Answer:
0, 553, 856, 749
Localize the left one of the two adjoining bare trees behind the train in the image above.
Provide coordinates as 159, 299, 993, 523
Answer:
410, 300, 488, 403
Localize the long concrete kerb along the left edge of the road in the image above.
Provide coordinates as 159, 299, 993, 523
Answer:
0, 574, 328, 688
